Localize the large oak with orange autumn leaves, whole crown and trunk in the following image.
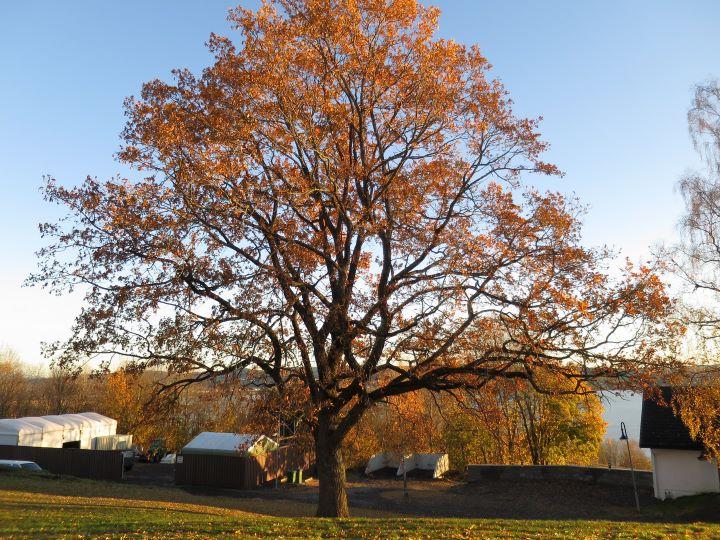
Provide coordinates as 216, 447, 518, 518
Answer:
35, 0, 668, 516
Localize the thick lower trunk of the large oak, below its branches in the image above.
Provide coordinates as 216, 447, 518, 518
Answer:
315, 413, 350, 517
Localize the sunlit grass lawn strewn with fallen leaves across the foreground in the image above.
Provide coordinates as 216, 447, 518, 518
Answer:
0, 473, 720, 538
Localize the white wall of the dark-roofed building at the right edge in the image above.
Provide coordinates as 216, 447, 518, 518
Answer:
651, 449, 720, 499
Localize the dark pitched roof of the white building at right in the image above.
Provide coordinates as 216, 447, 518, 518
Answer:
640, 386, 703, 450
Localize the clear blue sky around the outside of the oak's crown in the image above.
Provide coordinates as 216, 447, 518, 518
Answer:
0, 0, 720, 368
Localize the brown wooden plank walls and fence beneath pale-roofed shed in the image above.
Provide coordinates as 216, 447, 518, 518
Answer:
175, 446, 314, 489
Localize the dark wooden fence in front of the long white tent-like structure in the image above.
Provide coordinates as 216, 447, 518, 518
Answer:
0, 445, 123, 480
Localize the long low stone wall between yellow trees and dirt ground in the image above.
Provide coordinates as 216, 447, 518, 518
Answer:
467, 465, 653, 488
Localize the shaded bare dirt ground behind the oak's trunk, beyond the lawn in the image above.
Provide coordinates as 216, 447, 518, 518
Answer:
187, 477, 720, 522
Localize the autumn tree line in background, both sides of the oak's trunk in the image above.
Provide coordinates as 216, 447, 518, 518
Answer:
0, 349, 650, 471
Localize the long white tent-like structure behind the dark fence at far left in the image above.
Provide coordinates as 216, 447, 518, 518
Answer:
0, 412, 117, 449
